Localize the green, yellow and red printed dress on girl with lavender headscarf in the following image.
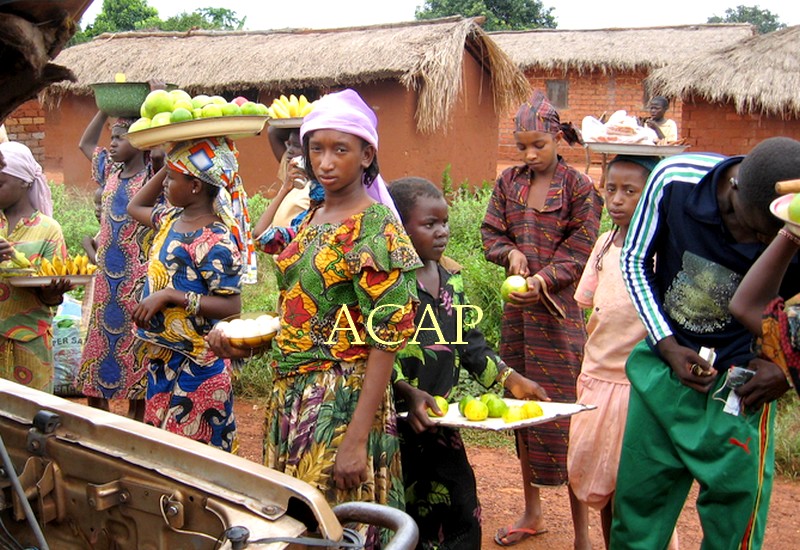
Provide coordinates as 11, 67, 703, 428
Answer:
257, 204, 421, 545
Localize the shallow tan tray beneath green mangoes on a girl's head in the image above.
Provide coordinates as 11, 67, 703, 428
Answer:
125, 115, 268, 149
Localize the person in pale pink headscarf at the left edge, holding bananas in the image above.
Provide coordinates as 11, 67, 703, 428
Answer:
0, 141, 70, 393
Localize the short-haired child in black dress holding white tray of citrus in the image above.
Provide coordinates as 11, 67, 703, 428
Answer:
389, 178, 547, 550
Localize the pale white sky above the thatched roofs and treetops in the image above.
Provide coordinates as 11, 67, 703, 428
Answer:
81, 0, 800, 30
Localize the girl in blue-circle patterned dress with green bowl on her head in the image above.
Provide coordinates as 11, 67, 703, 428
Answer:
78, 111, 161, 420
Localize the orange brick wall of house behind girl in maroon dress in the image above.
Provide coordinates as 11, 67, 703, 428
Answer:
498, 70, 682, 170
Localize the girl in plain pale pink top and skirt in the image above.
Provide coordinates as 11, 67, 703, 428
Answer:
567, 155, 674, 549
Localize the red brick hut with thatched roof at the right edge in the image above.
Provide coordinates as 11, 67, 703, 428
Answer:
648, 26, 800, 155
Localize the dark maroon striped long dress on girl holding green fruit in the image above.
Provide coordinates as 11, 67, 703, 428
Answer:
481, 157, 602, 486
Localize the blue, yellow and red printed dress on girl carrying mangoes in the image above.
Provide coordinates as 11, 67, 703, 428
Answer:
136, 208, 242, 452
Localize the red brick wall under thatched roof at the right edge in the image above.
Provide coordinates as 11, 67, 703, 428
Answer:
680, 100, 800, 155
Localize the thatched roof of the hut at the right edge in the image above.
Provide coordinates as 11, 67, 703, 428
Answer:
649, 26, 800, 116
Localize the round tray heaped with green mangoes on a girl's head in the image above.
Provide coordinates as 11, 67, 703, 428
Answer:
127, 89, 269, 149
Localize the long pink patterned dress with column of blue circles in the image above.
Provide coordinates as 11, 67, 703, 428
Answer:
78, 148, 153, 399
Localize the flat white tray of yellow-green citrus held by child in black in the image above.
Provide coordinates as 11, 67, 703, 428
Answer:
399, 393, 596, 432
